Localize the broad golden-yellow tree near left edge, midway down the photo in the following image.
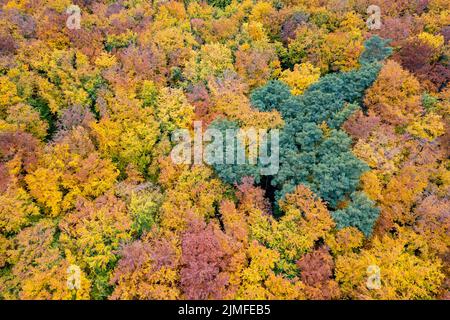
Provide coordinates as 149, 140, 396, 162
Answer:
25, 131, 118, 216
